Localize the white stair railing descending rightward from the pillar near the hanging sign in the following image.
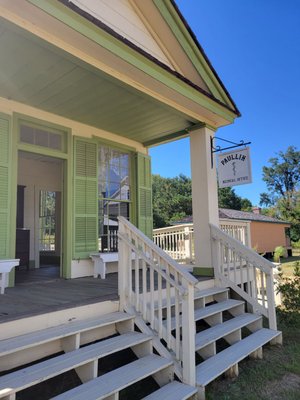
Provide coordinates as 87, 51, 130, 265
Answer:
210, 224, 277, 329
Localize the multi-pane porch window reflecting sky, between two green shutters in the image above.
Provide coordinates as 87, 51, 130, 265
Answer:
98, 146, 131, 252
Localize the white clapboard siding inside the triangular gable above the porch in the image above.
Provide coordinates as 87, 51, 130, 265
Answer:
71, 0, 172, 67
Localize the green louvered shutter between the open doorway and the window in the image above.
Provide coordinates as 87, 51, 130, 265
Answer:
74, 139, 98, 258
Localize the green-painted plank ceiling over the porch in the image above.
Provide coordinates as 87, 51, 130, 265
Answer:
0, 18, 197, 143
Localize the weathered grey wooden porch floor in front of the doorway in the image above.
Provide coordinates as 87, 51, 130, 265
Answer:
0, 266, 118, 323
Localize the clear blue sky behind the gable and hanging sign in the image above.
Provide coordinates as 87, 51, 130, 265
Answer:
150, 0, 300, 205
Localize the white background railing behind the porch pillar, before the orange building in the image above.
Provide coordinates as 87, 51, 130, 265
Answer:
153, 218, 251, 264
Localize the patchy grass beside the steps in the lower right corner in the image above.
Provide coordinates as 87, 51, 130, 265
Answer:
207, 311, 300, 400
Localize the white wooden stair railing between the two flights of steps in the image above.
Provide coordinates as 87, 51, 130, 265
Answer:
118, 217, 198, 385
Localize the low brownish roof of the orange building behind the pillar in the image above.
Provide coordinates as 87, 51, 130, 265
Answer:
172, 208, 290, 225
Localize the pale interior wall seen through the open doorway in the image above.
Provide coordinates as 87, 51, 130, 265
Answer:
18, 153, 63, 266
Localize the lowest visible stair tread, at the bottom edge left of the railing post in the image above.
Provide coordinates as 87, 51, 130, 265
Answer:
143, 381, 197, 400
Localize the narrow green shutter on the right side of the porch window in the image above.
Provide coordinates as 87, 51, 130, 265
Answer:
137, 153, 153, 239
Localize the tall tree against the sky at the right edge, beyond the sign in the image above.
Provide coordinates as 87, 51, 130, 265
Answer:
260, 146, 300, 241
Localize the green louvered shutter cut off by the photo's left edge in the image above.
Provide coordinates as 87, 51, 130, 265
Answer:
0, 115, 11, 259
